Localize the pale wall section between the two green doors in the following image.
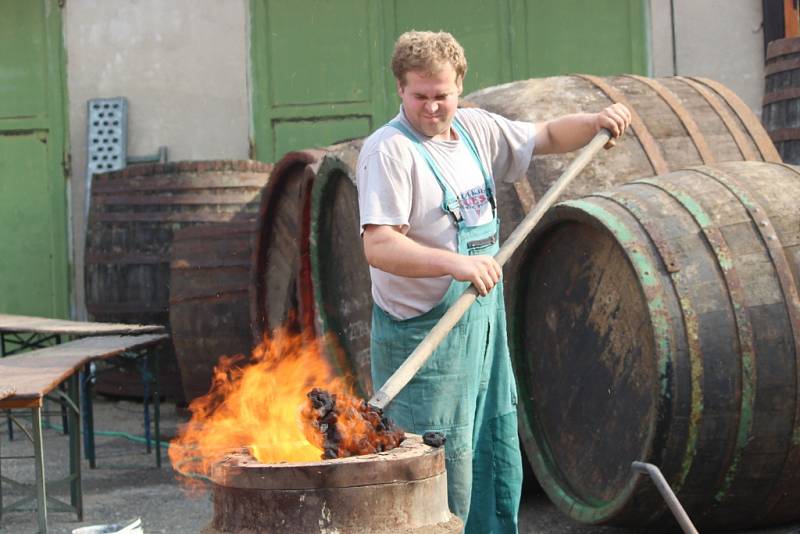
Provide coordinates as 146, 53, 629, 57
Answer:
64, 0, 250, 318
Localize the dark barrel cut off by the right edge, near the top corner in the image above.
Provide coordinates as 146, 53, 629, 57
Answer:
761, 37, 800, 164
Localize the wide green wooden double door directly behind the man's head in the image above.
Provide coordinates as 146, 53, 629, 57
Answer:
250, 0, 648, 161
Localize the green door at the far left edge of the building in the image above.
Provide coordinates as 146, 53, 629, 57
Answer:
0, 0, 69, 317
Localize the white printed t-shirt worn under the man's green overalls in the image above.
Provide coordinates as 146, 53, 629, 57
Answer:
356, 107, 535, 319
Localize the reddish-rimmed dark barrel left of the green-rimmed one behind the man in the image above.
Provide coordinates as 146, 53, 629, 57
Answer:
250, 149, 325, 343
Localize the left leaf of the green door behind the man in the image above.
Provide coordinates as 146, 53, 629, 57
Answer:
251, 0, 384, 161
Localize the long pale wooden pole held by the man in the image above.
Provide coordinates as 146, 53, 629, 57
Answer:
369, 129, 611, 410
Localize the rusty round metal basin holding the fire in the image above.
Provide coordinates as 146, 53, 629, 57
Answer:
204, 434, 463, 534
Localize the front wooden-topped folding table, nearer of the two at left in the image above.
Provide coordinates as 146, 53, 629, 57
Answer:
0, 334, 169, 533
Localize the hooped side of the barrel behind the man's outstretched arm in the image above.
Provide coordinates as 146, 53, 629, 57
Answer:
465, 75, 780, 239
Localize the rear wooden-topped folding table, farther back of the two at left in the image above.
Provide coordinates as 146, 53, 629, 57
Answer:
0, 314, 165, 469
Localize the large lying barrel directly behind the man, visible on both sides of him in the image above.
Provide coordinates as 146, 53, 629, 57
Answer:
310, 76, 780, 400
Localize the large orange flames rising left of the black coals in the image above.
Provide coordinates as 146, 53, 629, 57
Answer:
169, 329, 353, 477
